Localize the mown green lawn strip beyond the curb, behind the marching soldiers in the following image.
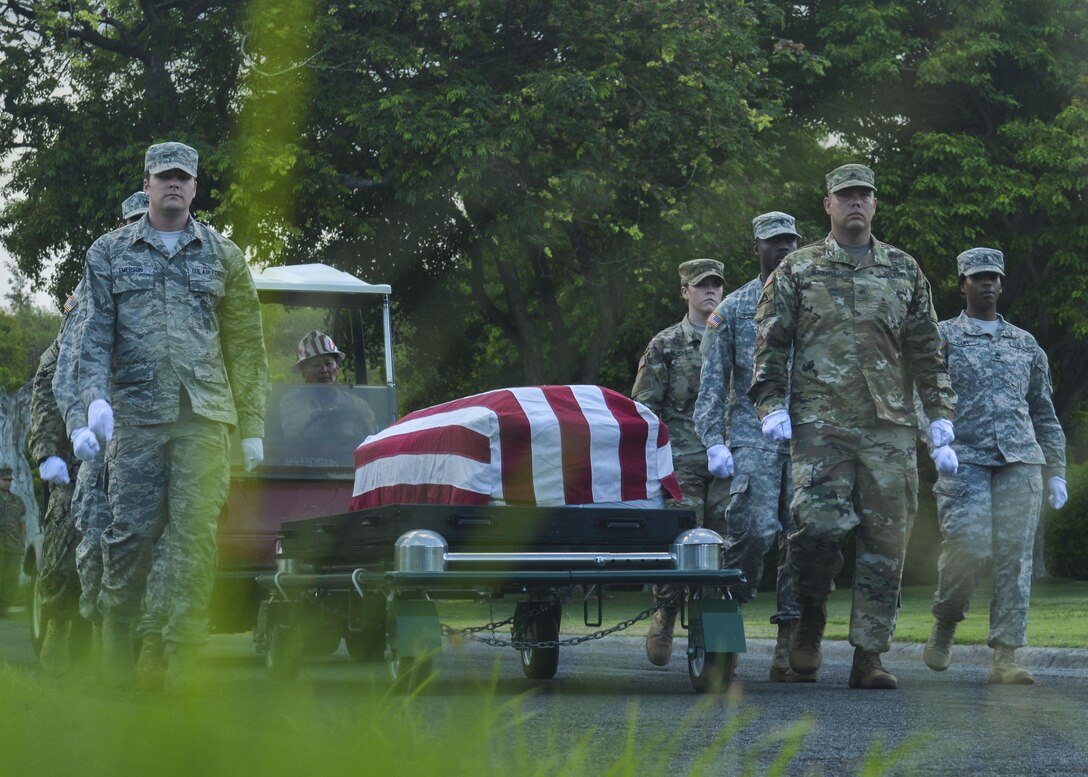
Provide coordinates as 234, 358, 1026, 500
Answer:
438, 579, 1088, 648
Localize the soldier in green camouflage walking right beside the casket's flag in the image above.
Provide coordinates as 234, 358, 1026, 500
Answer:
631, 259, 728, 666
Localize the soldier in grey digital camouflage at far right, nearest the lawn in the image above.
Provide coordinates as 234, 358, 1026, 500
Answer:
923, 248, 1066, 685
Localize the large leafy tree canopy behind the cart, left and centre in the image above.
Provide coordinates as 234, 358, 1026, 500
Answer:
0, 0, 781, 409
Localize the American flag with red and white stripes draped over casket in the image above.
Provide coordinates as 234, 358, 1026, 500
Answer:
350, 385, 680, 510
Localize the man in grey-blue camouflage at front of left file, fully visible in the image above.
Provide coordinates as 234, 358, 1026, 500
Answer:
62, 143, 269, 686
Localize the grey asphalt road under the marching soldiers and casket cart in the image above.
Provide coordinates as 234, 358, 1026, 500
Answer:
0, 620, 1088, 776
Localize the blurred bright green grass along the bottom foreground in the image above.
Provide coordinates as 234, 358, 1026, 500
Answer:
0, 664, 931, 777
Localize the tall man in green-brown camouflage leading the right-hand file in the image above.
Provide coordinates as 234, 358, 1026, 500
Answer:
749, 164, 955, 689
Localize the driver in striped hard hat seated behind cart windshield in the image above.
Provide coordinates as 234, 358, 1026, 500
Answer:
280, 330, 378, 461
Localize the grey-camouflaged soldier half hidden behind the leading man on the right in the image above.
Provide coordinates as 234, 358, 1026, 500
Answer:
694, 211, 816, 682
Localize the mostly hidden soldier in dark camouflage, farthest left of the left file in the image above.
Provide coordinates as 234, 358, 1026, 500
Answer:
27, 306, 81, 675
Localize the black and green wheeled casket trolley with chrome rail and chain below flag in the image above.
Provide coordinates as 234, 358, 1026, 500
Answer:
255, 505, 745, 692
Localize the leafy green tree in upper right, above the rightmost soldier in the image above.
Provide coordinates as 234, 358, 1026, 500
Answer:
775, 0, 1088, 422
